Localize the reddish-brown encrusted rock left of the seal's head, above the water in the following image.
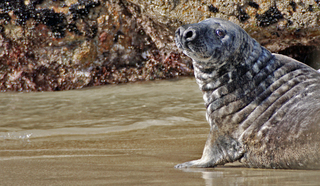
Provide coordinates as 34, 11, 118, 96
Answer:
0, 0, 192, 91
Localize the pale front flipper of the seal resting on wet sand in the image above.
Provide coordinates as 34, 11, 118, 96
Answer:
175, 133, 244, 168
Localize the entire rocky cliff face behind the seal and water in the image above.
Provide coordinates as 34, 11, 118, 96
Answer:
0, 0, 320, 91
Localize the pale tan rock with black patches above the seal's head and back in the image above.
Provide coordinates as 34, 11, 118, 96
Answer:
129, 0, 320, 68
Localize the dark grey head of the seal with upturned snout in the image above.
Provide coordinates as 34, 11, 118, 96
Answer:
175, 18, 254, 67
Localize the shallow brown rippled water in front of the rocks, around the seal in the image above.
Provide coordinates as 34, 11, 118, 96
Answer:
0, 78, 320, 186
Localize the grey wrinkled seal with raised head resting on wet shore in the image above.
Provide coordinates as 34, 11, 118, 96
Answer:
175, 18, 320, 169
